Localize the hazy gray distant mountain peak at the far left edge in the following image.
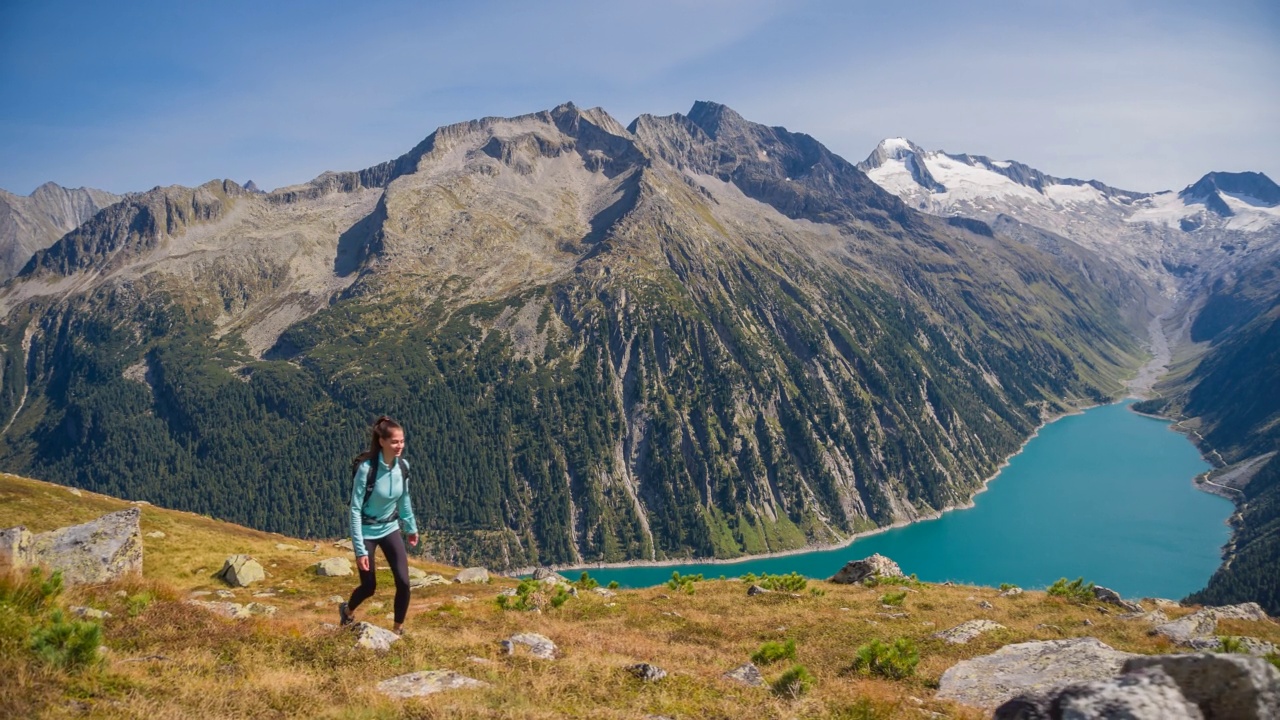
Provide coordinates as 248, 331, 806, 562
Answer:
0, 182, 120, 281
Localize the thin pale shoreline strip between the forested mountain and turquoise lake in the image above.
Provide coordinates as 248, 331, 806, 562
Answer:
503, 397, 1105, 578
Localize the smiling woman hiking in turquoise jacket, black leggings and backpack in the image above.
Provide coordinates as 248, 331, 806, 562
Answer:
338, 415, 417, 635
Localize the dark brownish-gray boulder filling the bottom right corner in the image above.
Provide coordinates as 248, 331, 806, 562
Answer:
1124, 652, 1280, 720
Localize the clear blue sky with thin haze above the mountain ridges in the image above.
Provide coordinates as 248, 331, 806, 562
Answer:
0, 0, 1280, 195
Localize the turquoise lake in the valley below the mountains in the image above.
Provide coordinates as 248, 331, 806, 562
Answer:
563, 401, 1233, 600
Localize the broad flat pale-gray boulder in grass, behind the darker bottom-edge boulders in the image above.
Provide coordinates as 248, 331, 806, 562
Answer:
937, 638, 1135, 707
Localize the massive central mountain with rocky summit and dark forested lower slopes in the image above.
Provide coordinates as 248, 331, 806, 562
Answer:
0, 102, 1142, 566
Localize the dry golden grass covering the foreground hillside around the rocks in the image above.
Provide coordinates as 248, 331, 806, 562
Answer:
0, 475, 1280, 720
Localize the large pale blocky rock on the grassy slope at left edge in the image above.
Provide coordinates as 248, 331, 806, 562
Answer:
0, 507, 142, 584
